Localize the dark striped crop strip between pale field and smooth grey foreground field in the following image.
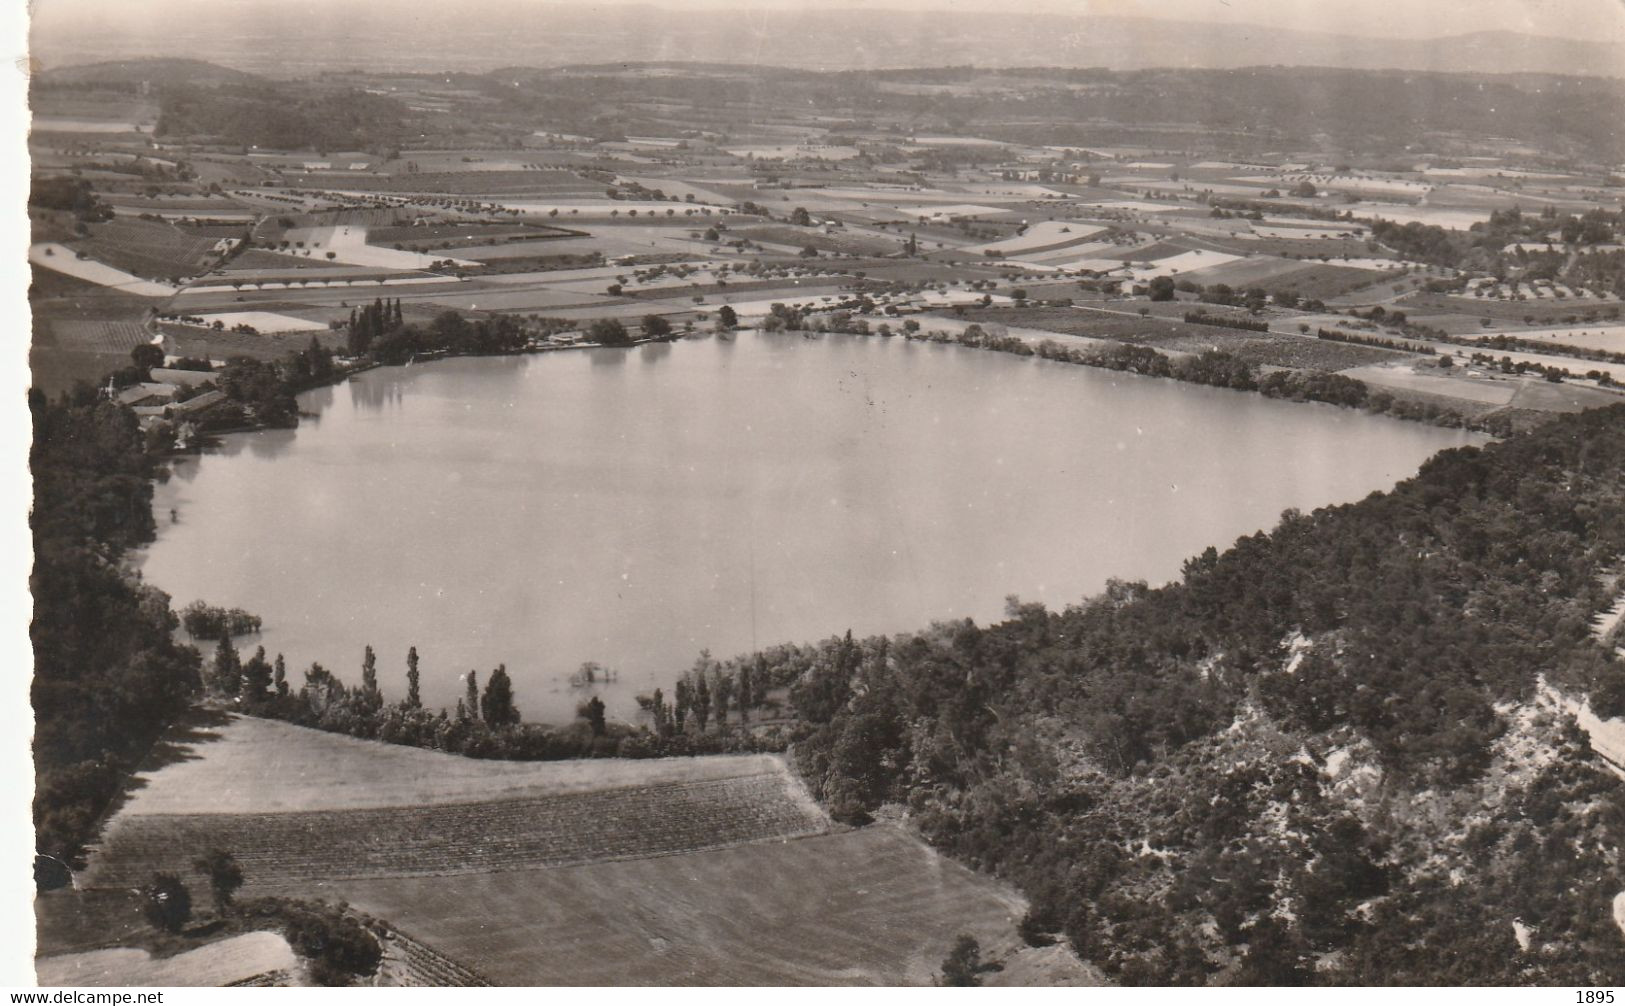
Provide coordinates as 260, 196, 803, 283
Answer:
83, 774, 827, 887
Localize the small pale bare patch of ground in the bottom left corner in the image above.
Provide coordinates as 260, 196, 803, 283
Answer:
34, 933, 299, 988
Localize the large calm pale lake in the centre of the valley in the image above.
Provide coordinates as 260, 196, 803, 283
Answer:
143, 333, 1479, 722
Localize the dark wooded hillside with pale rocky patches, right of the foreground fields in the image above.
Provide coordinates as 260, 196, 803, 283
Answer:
764, 406, 1625, 985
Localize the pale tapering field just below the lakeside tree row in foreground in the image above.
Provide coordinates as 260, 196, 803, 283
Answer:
101, 717, 799, 819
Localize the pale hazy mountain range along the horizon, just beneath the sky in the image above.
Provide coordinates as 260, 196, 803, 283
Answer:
22, 0, 1625, 78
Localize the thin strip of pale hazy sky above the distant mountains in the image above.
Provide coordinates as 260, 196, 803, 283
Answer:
31, 0, 1625, 42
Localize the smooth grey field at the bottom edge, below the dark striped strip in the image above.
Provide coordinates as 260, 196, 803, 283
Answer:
302, 824, 1025, 985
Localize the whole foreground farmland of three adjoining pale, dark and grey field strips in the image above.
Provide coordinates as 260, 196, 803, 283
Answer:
66, 717, 1024, 985
